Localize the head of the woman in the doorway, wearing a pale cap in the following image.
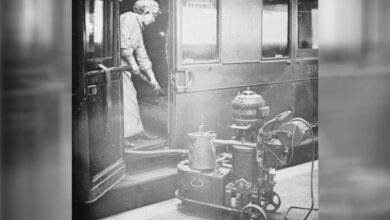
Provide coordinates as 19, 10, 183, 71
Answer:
133, 0, 161, 25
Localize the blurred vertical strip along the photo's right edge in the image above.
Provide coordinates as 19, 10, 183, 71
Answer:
318, 0, 390, 219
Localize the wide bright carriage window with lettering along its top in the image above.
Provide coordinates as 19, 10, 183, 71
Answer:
181, 0, 219, 63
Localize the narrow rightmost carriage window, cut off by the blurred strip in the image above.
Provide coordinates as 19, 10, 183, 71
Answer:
298, 0, 318, 49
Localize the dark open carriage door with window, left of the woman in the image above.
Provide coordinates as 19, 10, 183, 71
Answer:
73, 0, 125, 205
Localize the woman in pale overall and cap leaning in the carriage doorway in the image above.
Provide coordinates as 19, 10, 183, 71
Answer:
120, 0, 161, 142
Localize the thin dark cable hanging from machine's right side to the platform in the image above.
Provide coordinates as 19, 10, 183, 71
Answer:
285, 118, 318, 220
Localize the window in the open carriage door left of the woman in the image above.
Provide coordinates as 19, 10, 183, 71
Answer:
85, 0, 113, 65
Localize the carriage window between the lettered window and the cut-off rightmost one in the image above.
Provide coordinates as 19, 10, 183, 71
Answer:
262, 0, 290, 59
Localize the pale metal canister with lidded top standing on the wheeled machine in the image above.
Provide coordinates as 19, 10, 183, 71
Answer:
188, 127, 217, 170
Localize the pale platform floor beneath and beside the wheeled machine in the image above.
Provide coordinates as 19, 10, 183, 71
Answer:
106, 161, 318, 220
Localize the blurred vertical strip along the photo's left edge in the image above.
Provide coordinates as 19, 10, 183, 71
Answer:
0, 0, 72, 219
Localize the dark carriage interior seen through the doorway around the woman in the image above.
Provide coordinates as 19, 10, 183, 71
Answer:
120, 0, 169, 148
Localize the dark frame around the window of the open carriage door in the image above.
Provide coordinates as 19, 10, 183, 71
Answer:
84, 0, 115, 72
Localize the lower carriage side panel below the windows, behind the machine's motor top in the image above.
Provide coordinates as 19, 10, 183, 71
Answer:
173, 60, 318, 148
